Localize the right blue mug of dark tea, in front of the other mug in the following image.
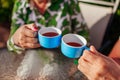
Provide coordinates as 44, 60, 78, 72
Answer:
61, 33, 89, 58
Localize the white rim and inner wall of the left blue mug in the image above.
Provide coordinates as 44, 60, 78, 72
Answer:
38, 27, 62, 38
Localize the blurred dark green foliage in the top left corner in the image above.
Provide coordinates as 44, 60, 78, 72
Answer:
0, 0, 15, 22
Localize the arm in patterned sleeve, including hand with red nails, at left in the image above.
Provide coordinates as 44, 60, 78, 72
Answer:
7, 0, 40, 53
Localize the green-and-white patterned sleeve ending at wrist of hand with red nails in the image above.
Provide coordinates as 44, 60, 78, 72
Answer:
7, 0, 24, 53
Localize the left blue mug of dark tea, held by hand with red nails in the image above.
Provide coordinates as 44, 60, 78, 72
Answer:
38, 27, 62, 48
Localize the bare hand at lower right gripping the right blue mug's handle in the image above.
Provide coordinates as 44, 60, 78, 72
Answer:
78, 46, 120, 80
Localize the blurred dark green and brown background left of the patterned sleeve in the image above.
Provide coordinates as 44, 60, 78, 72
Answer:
0, 0, 15, 48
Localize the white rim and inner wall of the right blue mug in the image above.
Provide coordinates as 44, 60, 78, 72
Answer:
62, 33, 87, 48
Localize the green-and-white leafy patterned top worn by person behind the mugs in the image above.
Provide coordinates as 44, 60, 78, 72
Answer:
7, 0, 85, 53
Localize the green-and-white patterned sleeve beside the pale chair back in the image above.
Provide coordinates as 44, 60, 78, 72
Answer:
68, 0, 88, 39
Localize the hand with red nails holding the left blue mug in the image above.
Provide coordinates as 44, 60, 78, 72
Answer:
13, 24, 40, 49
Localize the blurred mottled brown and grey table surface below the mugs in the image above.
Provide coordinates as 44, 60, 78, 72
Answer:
0, 48, 87, 80
